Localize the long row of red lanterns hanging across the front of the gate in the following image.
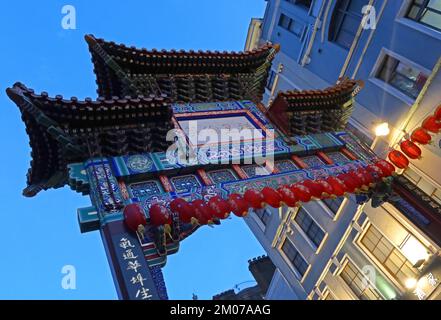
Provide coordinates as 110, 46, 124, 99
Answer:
124, 159, 395, 232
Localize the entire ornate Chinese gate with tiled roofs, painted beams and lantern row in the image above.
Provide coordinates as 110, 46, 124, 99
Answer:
7, 35, 393, 300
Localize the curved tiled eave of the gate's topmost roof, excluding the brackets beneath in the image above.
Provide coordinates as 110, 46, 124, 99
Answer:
85, 35, 279, 97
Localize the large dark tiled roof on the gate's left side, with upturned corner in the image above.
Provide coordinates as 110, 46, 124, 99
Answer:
6, 83, 173, 196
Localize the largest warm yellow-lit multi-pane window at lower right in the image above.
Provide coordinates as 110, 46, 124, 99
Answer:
360, 225, 419, 286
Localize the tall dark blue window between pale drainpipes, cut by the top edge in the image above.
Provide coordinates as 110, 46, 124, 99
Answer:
329, 0, 368, 49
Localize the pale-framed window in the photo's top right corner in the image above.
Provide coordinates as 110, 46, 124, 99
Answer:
406, 0, 441, 31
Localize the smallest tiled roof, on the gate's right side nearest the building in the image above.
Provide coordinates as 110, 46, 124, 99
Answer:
267, 78, 363, 137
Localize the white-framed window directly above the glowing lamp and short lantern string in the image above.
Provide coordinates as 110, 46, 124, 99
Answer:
376, 55, 427, 99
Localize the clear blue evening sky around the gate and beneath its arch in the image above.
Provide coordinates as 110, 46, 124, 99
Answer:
0, 0, 265, 299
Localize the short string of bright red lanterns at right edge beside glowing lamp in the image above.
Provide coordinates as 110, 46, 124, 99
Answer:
388, 105, 441, 169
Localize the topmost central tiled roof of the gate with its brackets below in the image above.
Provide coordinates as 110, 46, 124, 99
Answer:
85, 35, 279, 102
